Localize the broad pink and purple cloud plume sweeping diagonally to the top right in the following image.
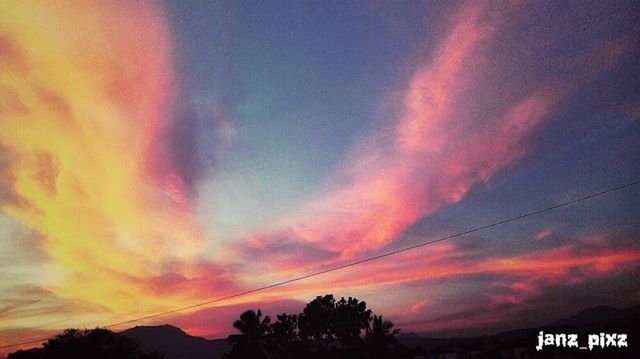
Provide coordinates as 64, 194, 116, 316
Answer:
233, 2, 631, 284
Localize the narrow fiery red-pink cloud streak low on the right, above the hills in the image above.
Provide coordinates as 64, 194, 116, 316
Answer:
273, 234, 640, 305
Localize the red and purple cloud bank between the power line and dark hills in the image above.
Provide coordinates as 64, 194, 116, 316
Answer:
149, 232, 640, 344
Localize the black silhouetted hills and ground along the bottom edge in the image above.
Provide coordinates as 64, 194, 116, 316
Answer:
8, 304, 640, 359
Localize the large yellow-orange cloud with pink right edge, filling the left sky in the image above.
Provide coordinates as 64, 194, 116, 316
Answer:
0, 1, 234, 327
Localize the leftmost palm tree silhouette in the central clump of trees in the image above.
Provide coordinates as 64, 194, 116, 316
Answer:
227, 309, 271, 359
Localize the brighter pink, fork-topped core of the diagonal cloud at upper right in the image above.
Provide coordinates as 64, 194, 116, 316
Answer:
235, 3, 554, 265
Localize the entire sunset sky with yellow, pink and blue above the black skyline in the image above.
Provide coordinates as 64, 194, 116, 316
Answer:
0, 1, 640, 354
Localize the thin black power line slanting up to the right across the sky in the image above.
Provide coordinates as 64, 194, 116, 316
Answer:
0, 180, 640, 349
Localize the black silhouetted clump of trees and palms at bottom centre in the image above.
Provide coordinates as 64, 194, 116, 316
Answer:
223, 294, 413, 359
